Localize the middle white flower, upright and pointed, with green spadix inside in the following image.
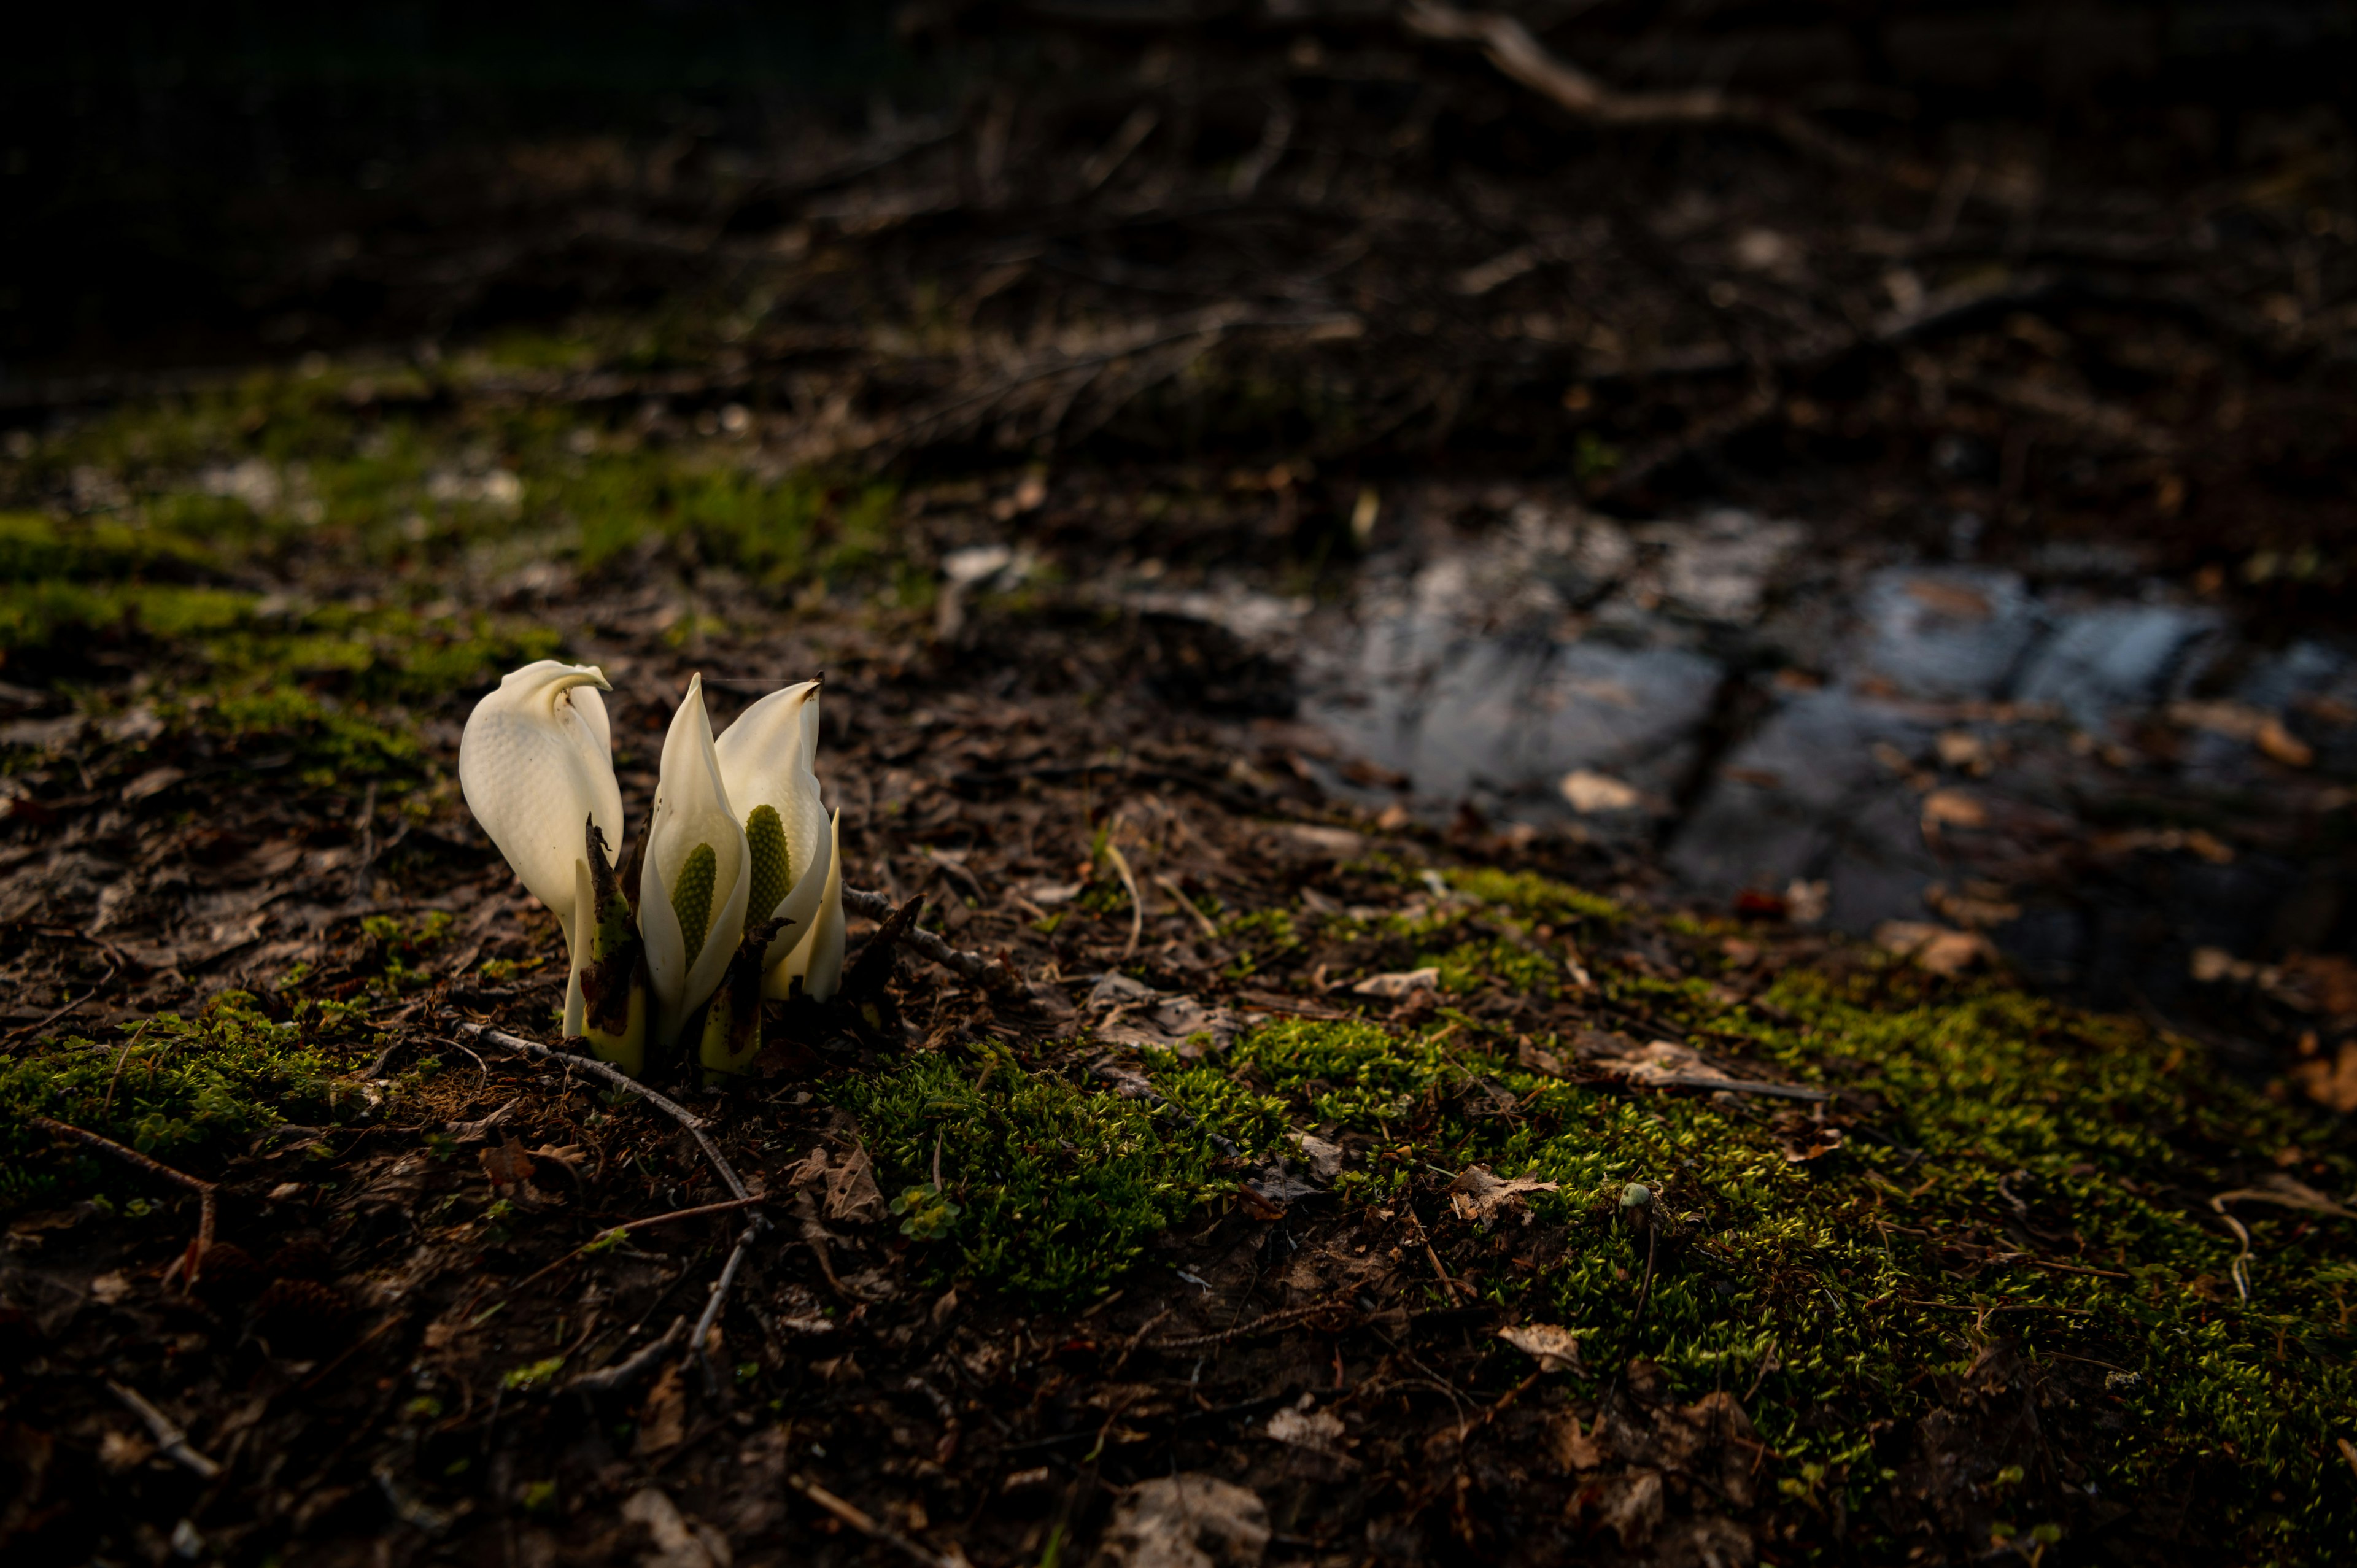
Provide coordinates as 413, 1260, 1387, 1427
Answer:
639, 674, 752, 1049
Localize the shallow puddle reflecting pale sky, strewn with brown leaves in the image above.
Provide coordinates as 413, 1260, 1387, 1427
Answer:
1162, 502, 2357, 1032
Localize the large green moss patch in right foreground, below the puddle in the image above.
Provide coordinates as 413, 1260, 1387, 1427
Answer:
1112, 971, 2357, 1549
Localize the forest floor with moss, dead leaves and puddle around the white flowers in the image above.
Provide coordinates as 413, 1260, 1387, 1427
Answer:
0, 7, 2357, 1568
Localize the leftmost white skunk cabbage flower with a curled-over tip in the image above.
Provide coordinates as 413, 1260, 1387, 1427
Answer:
457, 658, 622, 1035
